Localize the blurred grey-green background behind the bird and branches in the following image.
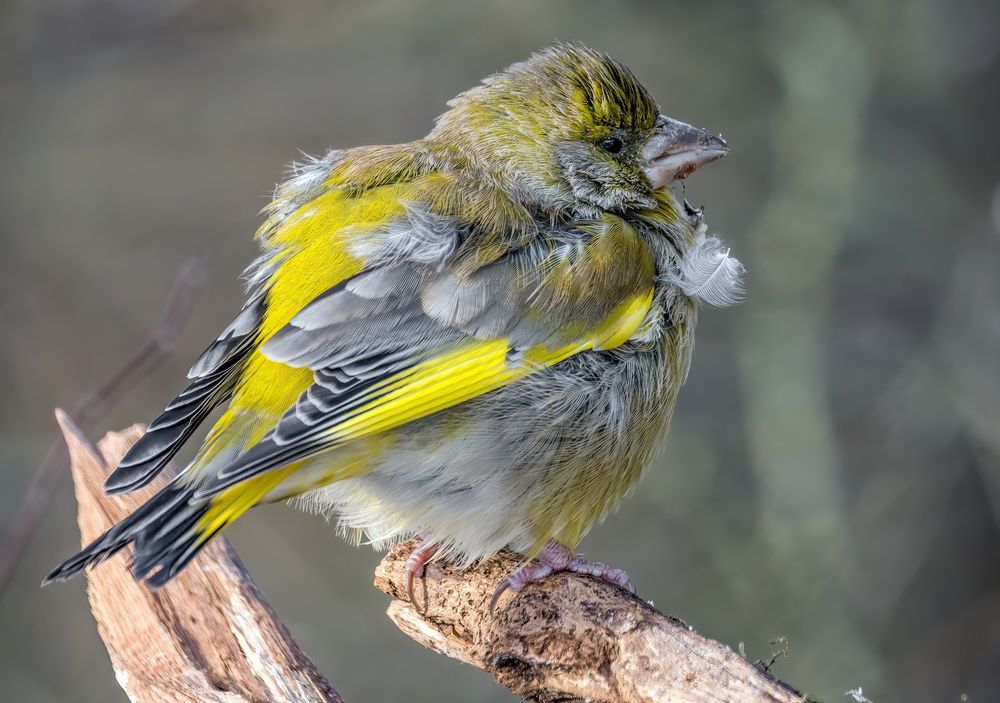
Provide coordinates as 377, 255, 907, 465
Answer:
0, 0, 1000, 703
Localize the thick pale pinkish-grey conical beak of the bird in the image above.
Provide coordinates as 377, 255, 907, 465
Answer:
642, 115, 729, 188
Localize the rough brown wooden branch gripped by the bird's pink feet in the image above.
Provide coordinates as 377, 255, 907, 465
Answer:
375, 542, 807, 703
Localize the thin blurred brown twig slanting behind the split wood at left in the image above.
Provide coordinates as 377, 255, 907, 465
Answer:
0, 258, 204, 598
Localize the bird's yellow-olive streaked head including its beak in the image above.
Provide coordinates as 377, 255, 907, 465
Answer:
428, 44, 729, 213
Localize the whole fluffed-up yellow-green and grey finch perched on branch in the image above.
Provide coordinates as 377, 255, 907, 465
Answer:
45, 43, 745, 609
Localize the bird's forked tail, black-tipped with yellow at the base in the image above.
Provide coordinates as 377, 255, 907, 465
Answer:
43, 469, 289, 586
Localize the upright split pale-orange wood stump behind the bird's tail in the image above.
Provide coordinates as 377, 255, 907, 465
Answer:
56, 411, 341, 703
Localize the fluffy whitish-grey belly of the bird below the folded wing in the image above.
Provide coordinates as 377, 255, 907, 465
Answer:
299, 354, 676, 562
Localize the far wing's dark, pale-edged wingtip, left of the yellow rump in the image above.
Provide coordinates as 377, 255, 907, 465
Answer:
104, 294, 264, 495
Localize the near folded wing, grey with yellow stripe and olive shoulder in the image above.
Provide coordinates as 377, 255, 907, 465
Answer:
194, 212, 654, 500
